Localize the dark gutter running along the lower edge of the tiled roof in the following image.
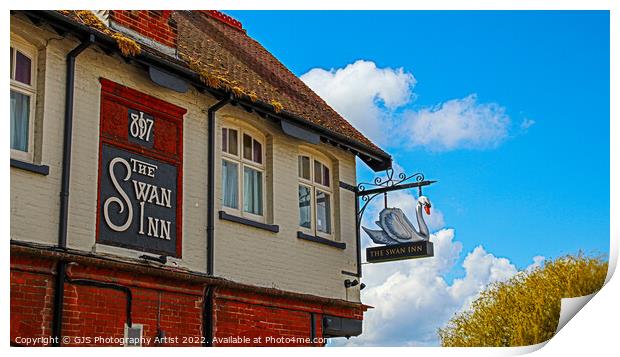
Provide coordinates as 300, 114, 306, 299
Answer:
25, 10, 392, 171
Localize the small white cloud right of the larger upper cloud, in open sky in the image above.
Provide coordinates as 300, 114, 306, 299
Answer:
402, 94, 510, 151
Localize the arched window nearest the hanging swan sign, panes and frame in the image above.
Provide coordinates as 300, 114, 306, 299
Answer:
297, 155, 333, 238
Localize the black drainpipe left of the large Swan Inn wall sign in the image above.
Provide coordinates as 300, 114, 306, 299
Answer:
52, 34, 95, 346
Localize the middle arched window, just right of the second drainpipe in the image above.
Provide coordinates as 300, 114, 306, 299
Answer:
222, 127, 265, 221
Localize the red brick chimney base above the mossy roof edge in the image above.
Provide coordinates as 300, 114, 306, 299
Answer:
110, 10, 177, 48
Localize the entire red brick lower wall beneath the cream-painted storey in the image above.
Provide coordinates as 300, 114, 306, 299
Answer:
10, 249, 364, 346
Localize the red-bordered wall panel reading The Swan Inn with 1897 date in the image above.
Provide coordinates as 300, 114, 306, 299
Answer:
97, 78, 186, 257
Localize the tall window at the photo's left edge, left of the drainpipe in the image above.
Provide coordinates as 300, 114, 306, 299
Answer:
10, 37, 36, 161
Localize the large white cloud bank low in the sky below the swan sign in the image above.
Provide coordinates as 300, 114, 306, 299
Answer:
331, 229, 540, 346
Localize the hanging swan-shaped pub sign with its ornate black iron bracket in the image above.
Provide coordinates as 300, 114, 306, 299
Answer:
356, 169, 435, 263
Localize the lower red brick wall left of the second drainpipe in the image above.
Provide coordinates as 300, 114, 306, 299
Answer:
11, 255, 203, 346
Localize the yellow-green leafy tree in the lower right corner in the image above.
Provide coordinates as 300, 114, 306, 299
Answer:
438, 253, 607, 347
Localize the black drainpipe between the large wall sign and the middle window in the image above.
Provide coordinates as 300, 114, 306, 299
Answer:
207, 96, 231, 276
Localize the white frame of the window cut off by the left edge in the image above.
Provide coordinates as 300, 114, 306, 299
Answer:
10, 34, 37, 163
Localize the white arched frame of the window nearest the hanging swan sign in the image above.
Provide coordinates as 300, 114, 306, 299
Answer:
297, 151, 335, 240
